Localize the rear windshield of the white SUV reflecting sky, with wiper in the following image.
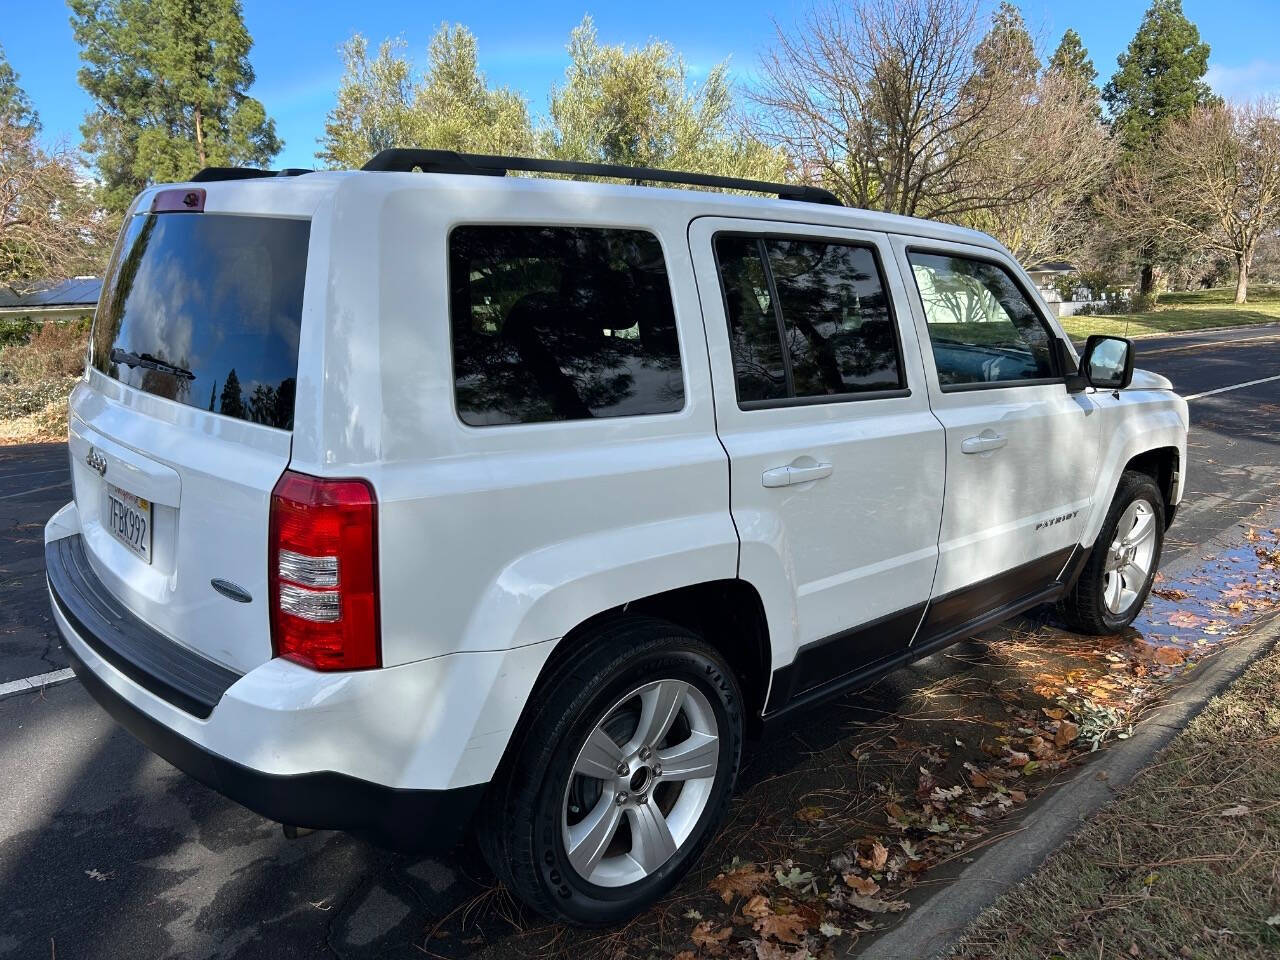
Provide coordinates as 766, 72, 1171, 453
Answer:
93, 214, 311, 430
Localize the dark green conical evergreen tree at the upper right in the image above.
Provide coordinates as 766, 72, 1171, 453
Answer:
1102, 0, 1215, 152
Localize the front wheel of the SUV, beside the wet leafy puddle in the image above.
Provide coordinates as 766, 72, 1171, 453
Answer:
1057, 471, 1165, 636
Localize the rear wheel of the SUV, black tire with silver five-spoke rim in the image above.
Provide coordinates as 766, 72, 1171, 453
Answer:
479, 618, 744, 925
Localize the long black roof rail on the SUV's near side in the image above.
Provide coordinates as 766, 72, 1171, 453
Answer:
360, 147, 844, 206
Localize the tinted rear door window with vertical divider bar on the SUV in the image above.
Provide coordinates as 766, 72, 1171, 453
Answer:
716, 234, 905, 404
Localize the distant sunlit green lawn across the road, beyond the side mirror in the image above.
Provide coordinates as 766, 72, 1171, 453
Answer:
1060, 284, 1280, 339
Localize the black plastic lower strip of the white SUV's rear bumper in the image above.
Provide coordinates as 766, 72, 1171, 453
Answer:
63, 644, 485, 851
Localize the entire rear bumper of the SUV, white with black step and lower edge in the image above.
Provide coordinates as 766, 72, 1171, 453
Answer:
46, 504, 519, 850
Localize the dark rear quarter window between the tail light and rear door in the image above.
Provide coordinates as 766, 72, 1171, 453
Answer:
449, 225, 685, 426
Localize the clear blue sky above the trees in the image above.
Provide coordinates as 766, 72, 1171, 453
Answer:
0, 0, 1280, 166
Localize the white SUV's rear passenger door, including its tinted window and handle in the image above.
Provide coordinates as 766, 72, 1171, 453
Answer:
690, 218, 943, 710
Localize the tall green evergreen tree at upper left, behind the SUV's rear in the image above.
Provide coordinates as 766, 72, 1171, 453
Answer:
68, 0, 283, 210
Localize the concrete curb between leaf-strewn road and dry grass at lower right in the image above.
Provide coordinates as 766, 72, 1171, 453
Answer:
844, 618, 1280, 960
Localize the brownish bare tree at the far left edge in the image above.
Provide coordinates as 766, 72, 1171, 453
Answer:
0, 118, 110, 289
